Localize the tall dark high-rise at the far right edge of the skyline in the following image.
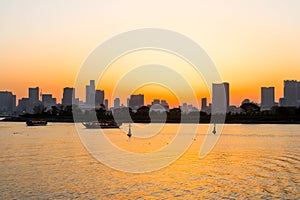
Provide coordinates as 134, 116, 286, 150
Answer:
280, 80, 300, 106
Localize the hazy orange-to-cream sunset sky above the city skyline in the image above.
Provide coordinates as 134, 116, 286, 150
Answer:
0, 0, 300, 106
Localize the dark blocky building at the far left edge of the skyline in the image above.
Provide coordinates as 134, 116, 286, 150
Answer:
0, 91, 16, 115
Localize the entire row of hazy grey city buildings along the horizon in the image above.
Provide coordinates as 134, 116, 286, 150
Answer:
0, 80, 300, 116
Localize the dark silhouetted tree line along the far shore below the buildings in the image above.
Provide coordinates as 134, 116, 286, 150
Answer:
7, 103, 300, 123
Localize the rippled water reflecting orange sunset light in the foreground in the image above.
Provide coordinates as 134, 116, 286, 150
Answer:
0, 122, 300, 199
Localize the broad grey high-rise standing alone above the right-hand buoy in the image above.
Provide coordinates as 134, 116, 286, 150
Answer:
212, 83, 230, 113
